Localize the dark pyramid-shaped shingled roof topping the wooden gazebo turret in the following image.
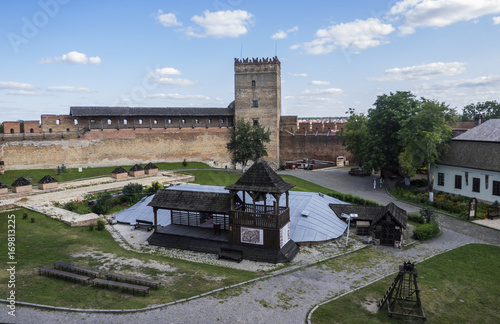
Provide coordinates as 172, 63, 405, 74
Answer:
225, 159, 295, 194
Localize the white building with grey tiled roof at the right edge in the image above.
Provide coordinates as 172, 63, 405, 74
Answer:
431, 119, 500, 202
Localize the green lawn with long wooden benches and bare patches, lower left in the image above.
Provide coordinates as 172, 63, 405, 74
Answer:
0, 209, 259, 309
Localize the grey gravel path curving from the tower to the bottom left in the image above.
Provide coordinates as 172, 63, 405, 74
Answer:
0, 169, 500, 324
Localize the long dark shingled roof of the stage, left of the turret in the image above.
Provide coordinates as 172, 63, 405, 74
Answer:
148, 189, 236, 214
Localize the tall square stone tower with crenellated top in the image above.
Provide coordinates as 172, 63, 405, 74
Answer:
234, 57, 281, 168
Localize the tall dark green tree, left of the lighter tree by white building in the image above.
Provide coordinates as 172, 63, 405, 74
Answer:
361, 91, 419, 172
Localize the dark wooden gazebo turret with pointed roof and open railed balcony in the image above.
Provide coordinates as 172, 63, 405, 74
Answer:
225, 159, 294, 249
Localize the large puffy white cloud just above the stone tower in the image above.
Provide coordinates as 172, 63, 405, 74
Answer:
190, 10, 254, 38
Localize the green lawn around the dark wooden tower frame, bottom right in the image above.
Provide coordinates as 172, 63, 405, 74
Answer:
312, 244, 500, 324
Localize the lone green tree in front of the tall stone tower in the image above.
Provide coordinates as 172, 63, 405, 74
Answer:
226, 119, 271, 172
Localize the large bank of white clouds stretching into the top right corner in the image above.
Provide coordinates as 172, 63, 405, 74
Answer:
290, 0, 500, 54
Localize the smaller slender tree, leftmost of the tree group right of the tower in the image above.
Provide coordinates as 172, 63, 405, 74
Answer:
343, 108, 370, 166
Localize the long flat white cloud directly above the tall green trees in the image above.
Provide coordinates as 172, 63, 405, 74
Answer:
368, 62, 467, 81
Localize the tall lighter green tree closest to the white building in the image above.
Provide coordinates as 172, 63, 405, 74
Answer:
398, 98, 456, 188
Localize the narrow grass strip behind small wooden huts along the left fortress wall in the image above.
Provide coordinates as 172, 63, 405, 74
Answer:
0, 162, 210, 188
